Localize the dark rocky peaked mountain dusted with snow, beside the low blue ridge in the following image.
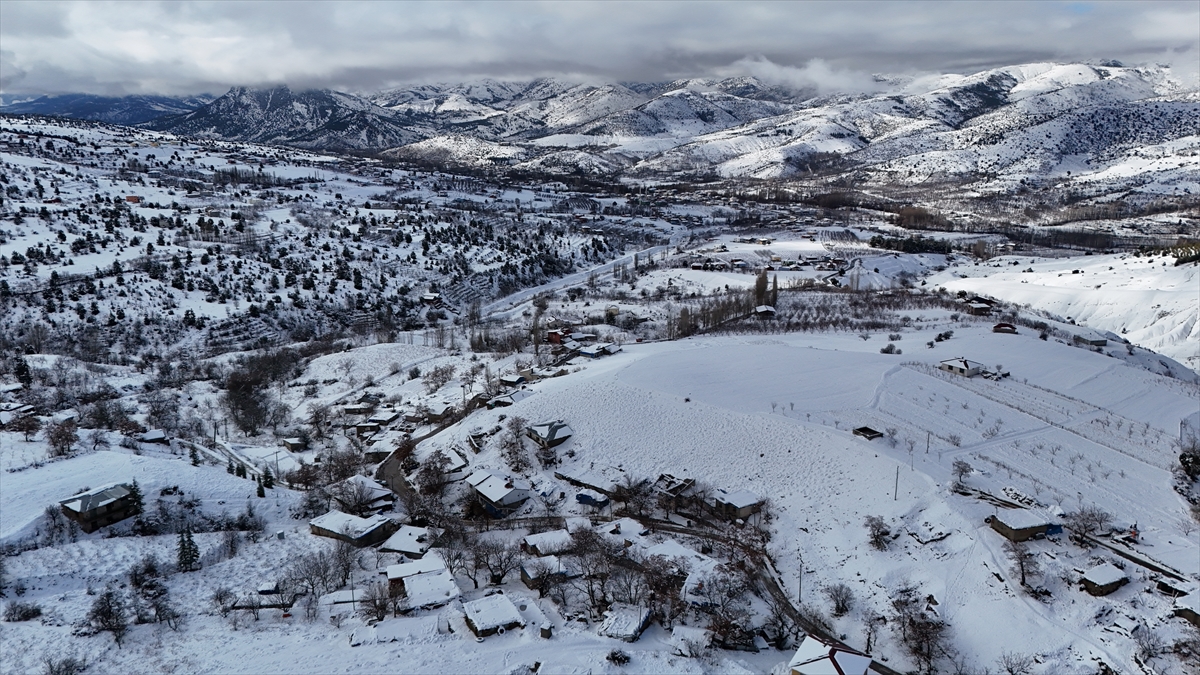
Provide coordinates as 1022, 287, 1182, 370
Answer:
146, 86, 426, 150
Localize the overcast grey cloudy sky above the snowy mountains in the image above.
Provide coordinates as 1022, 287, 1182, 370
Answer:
0, 0, 1200, 97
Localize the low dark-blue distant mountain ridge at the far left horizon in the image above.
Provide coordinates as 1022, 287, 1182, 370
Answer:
0, 94, 214, 125
